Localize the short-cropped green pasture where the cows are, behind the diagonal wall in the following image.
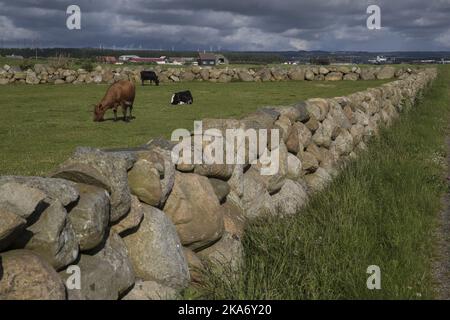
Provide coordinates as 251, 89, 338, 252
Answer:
0, 81, 390, 175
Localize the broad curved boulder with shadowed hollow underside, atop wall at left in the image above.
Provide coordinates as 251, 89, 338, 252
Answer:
52, 148, 132, 222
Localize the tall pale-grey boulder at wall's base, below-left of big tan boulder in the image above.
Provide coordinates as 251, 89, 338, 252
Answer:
124, 205, 189, 289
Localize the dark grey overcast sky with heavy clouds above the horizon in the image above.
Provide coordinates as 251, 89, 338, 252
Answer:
0, 0, 450, 51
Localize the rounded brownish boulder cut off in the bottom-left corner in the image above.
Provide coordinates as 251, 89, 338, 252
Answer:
0, 250, 66, 300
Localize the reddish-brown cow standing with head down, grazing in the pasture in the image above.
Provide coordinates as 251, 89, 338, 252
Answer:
94, 80, 136, 122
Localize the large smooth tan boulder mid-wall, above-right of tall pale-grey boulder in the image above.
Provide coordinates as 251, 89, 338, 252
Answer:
164, 173, 223, 250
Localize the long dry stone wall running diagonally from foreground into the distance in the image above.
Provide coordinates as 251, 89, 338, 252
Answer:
0, 69, 437, 300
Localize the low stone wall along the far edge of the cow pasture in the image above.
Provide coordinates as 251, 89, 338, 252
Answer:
0, 64, 416, 85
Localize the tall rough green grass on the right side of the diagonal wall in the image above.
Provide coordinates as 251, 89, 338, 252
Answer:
186, 67, 450, 299
